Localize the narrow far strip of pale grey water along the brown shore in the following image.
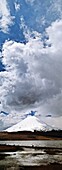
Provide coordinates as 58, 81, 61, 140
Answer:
0, 140, 62, 148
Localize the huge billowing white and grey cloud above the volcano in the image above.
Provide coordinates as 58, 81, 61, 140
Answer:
0, 20, 62, 129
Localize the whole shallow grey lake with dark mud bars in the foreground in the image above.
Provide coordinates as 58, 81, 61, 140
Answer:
0, 140, 62, 170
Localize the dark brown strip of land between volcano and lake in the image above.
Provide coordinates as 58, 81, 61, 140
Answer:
0, 131, 62, 140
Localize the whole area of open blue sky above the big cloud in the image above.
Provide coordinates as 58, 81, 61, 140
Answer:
0, 0, 60, 44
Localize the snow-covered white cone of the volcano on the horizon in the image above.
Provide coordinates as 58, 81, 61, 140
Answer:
5, 116, 49, 132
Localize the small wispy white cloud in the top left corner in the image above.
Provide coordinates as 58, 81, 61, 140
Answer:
0, 0, 14, 33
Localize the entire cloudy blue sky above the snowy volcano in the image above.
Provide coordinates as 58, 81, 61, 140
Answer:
0, 0, 62, 130
